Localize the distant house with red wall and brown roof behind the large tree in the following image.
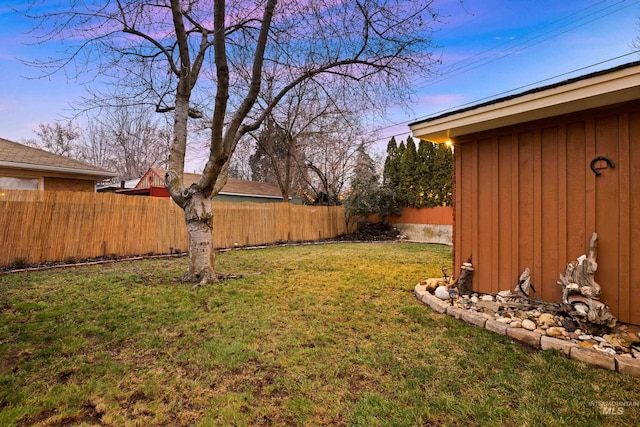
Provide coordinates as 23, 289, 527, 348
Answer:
116, 168, 282, 203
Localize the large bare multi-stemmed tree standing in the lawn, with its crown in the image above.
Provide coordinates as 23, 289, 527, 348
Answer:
21, 0, 436, 283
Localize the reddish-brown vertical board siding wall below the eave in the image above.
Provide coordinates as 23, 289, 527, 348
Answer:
454, 102, 640, 324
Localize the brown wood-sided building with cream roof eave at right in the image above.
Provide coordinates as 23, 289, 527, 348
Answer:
410, 62, 640, 324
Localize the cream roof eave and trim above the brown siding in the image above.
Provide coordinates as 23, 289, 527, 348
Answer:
409, 66, 640, 142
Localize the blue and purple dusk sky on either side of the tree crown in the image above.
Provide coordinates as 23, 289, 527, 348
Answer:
0, 0, 640, 171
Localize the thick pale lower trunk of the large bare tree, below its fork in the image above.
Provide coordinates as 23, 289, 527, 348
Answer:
182, 192, 217, 284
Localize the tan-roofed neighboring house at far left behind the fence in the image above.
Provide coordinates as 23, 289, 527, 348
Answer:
0, 138, 117, 191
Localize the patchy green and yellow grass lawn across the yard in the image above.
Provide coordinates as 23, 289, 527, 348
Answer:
0, 243, 640, 426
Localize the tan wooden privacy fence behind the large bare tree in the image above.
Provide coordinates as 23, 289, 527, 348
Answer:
0, 190, 346, 266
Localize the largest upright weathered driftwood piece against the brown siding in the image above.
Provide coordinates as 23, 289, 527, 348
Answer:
558, 233, 616, 326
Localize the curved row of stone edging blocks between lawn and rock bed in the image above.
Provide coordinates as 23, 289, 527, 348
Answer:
414, 284, 640, 377
